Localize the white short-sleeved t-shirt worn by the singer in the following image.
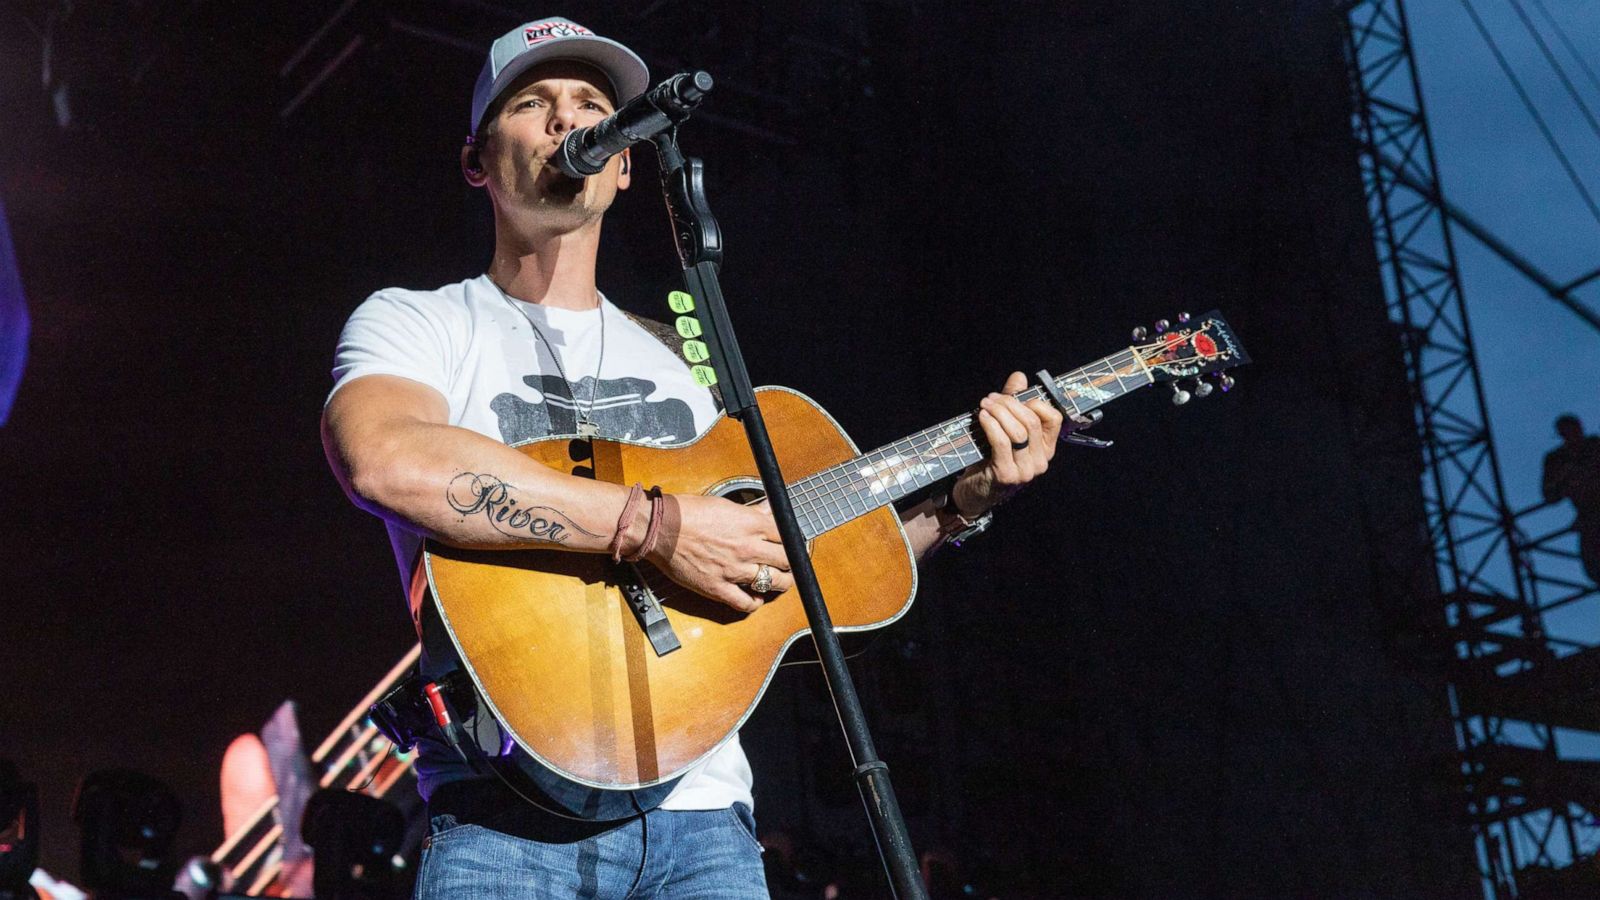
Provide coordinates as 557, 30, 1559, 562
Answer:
328, 275, 754, 809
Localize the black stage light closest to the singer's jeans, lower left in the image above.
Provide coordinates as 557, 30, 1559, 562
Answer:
301, 788, 406, 900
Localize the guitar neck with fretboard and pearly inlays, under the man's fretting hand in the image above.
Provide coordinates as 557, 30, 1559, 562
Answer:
789, 348, 1154, 538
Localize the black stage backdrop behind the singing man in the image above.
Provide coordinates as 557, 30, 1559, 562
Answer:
0, 0, 1477, 897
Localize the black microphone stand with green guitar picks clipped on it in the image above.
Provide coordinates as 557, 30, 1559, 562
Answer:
651, 128, 928, 900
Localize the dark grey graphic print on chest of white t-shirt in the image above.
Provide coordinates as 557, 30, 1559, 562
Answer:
490, 375, 694, 444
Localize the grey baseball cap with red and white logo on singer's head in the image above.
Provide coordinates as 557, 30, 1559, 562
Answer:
472, 16, 650, 135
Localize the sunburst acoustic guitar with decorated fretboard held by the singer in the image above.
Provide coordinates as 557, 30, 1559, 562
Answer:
424, 312, 1248, 790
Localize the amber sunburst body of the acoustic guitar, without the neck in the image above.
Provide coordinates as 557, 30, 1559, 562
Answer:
424, 388, 917, 790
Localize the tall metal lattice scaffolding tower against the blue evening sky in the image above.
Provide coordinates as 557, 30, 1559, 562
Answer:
1344, 0, 1600, 898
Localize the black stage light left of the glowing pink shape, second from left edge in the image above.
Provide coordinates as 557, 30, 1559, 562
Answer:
72, 769, 182, 898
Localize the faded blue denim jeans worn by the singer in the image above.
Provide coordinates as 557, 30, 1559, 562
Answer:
414, 794, 766, 900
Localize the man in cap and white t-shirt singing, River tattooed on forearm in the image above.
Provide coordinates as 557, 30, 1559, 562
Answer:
322, 18, 1062, 900
